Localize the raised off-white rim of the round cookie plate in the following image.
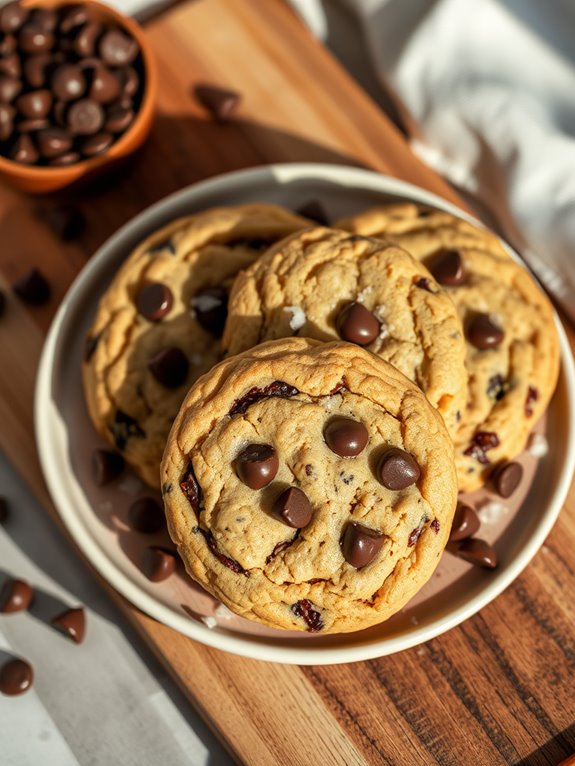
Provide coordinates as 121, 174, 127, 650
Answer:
34, 163, 575, 665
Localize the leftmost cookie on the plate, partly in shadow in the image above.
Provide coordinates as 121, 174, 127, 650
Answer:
83, 204, 308, 487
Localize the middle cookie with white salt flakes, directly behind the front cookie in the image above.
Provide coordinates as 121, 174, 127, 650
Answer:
223, 227, 467, 433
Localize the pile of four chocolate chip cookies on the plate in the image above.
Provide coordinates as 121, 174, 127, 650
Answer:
83, 204, 559, 633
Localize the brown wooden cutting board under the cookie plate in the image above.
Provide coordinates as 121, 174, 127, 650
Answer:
0, 0, 575, 766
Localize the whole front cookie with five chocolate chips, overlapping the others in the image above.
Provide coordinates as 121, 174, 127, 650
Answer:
162, 338, 457, 633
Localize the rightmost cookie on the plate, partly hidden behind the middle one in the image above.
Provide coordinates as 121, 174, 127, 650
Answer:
338, 204, 559, 491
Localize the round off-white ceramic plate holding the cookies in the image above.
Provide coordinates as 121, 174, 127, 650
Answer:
35, 164, 575, 665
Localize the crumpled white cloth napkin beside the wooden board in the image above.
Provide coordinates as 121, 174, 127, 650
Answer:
291, 0, 575, 321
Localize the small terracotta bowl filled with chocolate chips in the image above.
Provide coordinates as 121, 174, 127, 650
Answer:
0, 0, 157, 193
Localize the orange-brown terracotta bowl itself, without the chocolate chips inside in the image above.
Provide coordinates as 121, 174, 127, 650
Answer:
0, 0, 158, 194
